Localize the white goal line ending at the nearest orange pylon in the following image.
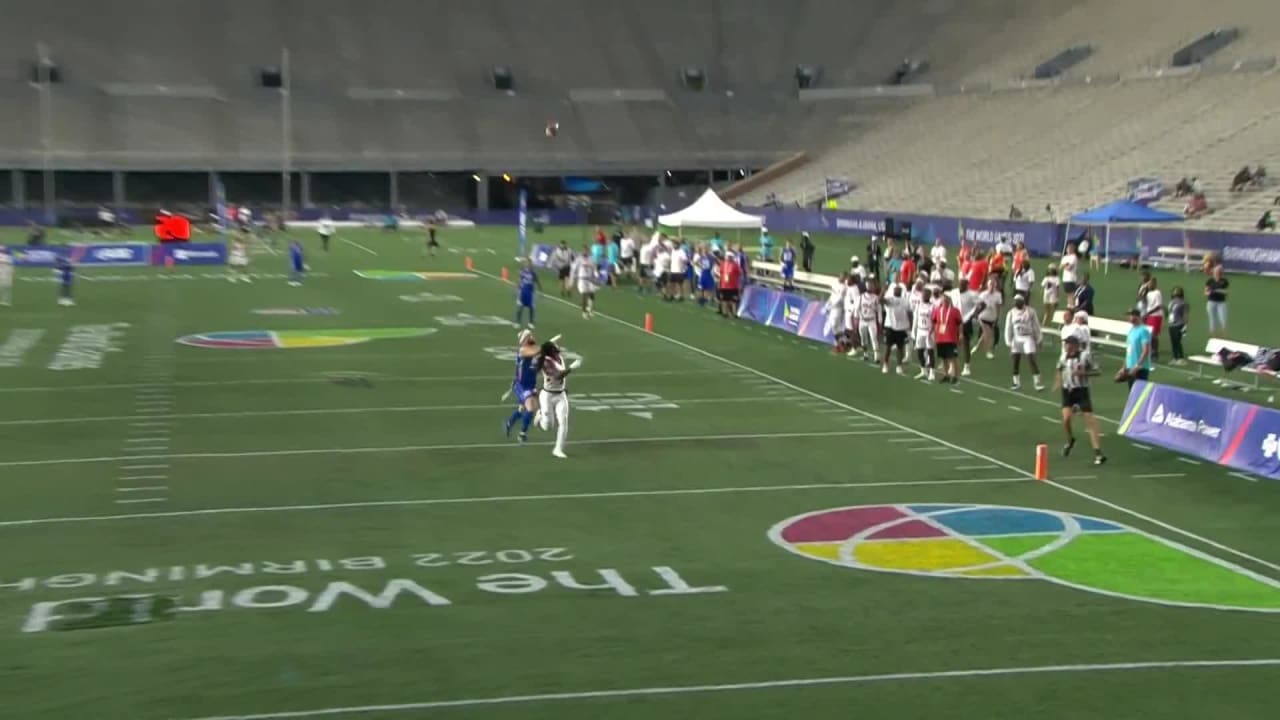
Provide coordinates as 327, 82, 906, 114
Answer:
0, 478, 1027, 528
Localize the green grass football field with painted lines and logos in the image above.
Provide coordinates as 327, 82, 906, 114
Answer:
0, 228, 1280, 720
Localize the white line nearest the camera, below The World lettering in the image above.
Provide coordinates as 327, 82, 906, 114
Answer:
172, 657, 1280, 720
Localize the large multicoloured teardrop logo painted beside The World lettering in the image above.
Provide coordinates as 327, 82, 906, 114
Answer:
769, 503, 1280, 612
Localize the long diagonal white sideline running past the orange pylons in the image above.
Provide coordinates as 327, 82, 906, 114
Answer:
476, 270, 1280, 574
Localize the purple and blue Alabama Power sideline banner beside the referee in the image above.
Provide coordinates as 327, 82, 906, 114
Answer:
1120, 382, 1280, 479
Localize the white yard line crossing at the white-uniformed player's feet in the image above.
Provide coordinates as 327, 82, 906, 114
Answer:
0, 429, 901, 468
